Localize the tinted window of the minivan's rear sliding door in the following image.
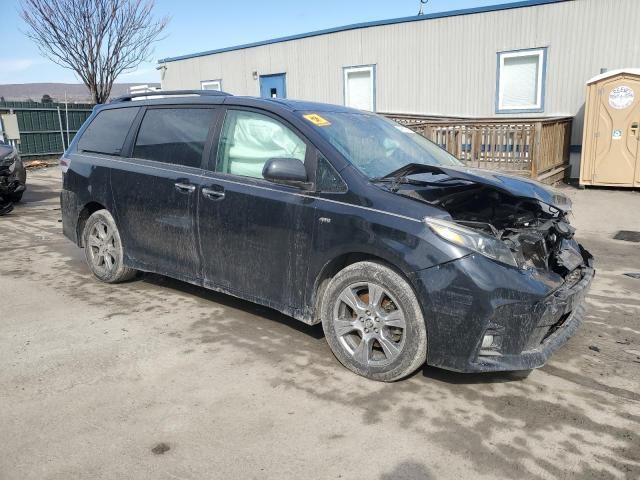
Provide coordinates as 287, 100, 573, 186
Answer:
133, 108, 215, 167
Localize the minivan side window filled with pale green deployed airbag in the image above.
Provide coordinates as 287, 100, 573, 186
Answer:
217, 110, 307, 178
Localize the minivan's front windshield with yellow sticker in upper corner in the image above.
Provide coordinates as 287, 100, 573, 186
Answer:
303, 112, 462, 178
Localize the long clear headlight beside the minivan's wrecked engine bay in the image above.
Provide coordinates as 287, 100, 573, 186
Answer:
424, 217, 518, 267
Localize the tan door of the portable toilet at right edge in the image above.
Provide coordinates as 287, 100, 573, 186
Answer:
593, 77, 640, 186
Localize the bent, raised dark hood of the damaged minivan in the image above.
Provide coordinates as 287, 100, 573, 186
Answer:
386, 163, 571, 212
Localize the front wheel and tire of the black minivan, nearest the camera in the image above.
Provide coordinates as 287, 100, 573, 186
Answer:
320, 261, 427, 382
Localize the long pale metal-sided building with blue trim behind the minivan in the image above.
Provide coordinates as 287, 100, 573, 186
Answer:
159, 0, 640, 176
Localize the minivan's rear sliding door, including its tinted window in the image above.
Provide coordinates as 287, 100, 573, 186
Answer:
111, 106, 216, 281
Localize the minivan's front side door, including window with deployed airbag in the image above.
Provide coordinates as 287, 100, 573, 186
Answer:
198, 109, 314, 314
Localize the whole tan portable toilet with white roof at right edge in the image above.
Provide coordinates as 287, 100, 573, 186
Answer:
580, 68, 640, 187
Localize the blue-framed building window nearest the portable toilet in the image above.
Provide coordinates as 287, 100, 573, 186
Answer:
496, 48, 547, 113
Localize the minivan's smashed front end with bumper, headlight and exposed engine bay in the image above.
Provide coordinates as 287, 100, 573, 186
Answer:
397, 167, 595, 372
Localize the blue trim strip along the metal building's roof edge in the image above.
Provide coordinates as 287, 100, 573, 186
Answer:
158, 0, 567, 63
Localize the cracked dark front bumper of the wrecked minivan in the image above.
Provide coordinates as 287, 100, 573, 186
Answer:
413, 250, 595, 372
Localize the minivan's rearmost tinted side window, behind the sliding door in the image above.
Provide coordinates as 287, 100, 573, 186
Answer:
78, 107, 140, 155
